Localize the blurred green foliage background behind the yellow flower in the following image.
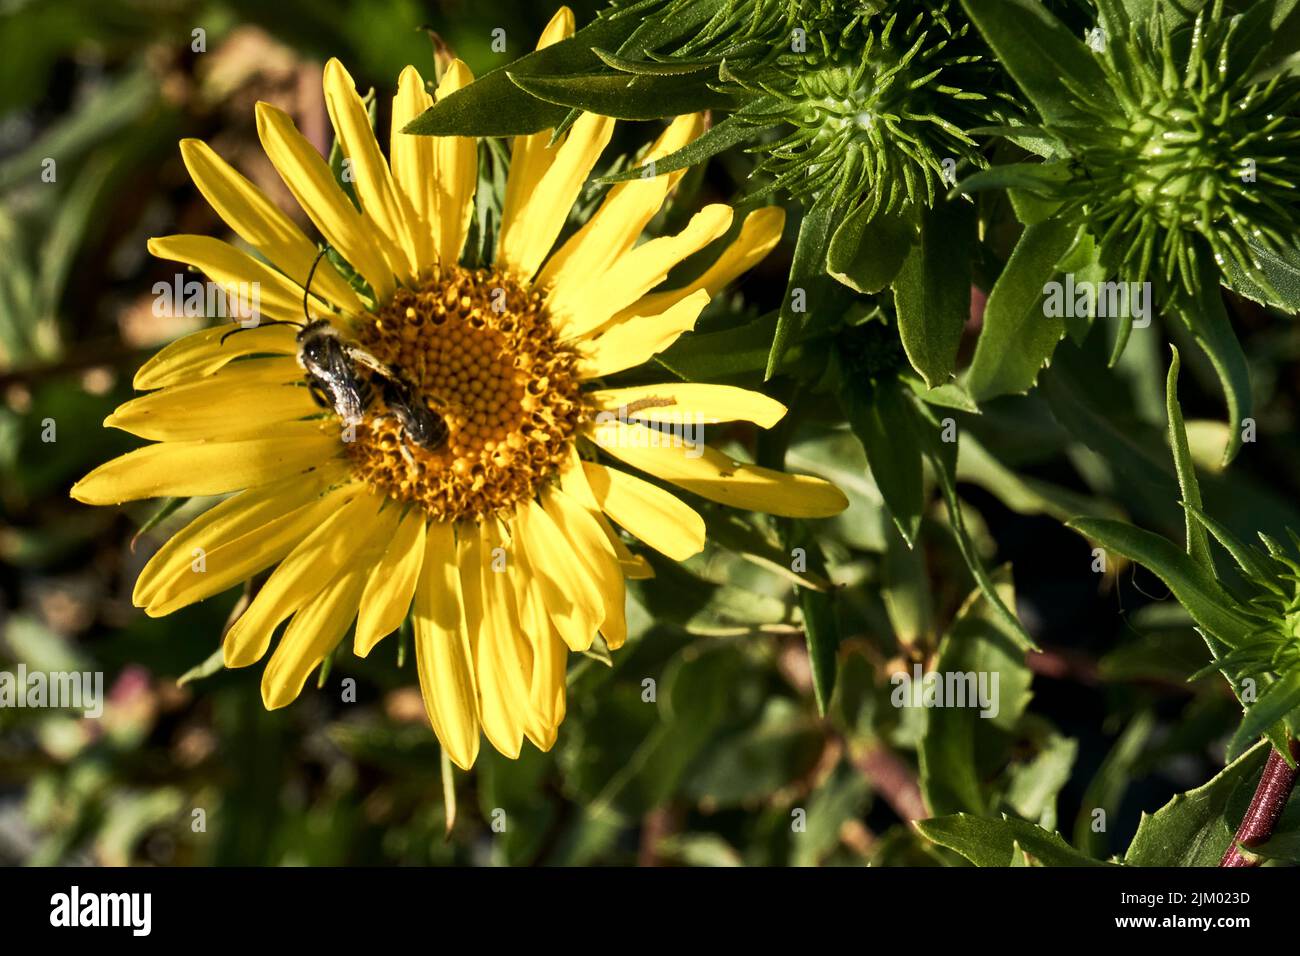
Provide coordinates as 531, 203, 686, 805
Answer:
0, 0, 1300, 865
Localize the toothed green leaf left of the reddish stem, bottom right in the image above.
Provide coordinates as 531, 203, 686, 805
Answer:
1125, 744, 1269, 866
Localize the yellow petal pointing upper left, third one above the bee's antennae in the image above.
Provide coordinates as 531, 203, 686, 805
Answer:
257, 103, 395, 302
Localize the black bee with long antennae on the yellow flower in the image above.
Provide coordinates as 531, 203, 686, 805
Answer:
221, 250, 450, 454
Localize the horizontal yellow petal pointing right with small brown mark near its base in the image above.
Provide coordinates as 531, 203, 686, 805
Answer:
586, 382, 785, 428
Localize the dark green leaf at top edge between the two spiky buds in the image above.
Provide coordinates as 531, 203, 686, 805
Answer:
962, 0, 1114, 124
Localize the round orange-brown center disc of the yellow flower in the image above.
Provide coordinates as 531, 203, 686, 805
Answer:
347, 267, 581, 520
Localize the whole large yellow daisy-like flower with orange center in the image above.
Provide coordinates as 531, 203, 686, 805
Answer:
73, 9, 846, 767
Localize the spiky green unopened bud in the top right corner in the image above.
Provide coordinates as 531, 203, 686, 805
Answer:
1056, 0, 1300, 294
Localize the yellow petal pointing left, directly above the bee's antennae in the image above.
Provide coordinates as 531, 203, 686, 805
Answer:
148, 235, 326, 325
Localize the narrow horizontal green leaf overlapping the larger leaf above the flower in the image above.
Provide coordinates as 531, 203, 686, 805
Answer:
507, 68, 736, 120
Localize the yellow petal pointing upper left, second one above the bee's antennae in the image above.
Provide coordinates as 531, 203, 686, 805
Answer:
181, 139, 364, 313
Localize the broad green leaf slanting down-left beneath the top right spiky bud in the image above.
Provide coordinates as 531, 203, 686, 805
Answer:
966, 220, 1078, 402
